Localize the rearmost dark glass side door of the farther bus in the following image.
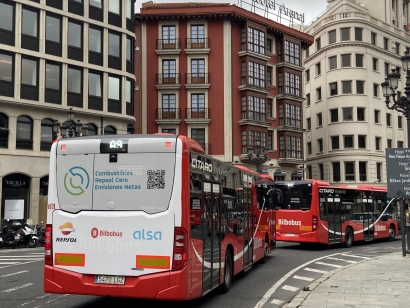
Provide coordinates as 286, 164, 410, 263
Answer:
327, 195, 342, 244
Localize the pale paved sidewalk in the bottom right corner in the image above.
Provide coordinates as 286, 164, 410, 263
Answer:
283, 252, 410, 308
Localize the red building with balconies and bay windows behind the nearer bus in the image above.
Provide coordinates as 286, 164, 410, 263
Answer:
135, 2, 313, 179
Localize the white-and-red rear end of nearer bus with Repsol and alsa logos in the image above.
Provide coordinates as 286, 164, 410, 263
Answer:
44, 135, 190, 300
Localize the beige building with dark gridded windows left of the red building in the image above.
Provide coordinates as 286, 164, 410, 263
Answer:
0, 0, 135, 223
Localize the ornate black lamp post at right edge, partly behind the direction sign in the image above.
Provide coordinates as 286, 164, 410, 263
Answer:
381, 50, 410, 256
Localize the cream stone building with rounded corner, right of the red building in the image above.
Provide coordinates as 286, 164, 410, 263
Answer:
304, 0, 410, 185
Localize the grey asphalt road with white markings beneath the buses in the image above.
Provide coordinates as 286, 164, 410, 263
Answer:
0, 238, 401, 308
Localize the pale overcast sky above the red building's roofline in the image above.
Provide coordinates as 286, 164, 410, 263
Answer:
135, 0, 327, 25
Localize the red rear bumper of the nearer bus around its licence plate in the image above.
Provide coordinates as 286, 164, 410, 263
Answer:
44, 265, 190, 300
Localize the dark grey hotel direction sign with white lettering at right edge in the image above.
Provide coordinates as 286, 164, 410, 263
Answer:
386, 148, 410, 198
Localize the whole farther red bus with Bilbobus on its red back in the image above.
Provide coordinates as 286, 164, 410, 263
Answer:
273, 180, 398, 247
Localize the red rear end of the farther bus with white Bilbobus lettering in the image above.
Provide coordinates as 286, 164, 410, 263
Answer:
274, 180, 329, 243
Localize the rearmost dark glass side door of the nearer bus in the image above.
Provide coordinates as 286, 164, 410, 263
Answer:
202, 182, 221, 293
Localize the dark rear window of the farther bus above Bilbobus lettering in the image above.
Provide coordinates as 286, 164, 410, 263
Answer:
274, 183, 312, 210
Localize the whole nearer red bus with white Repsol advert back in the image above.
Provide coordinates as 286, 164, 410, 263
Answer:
44, 134, 275, 300
